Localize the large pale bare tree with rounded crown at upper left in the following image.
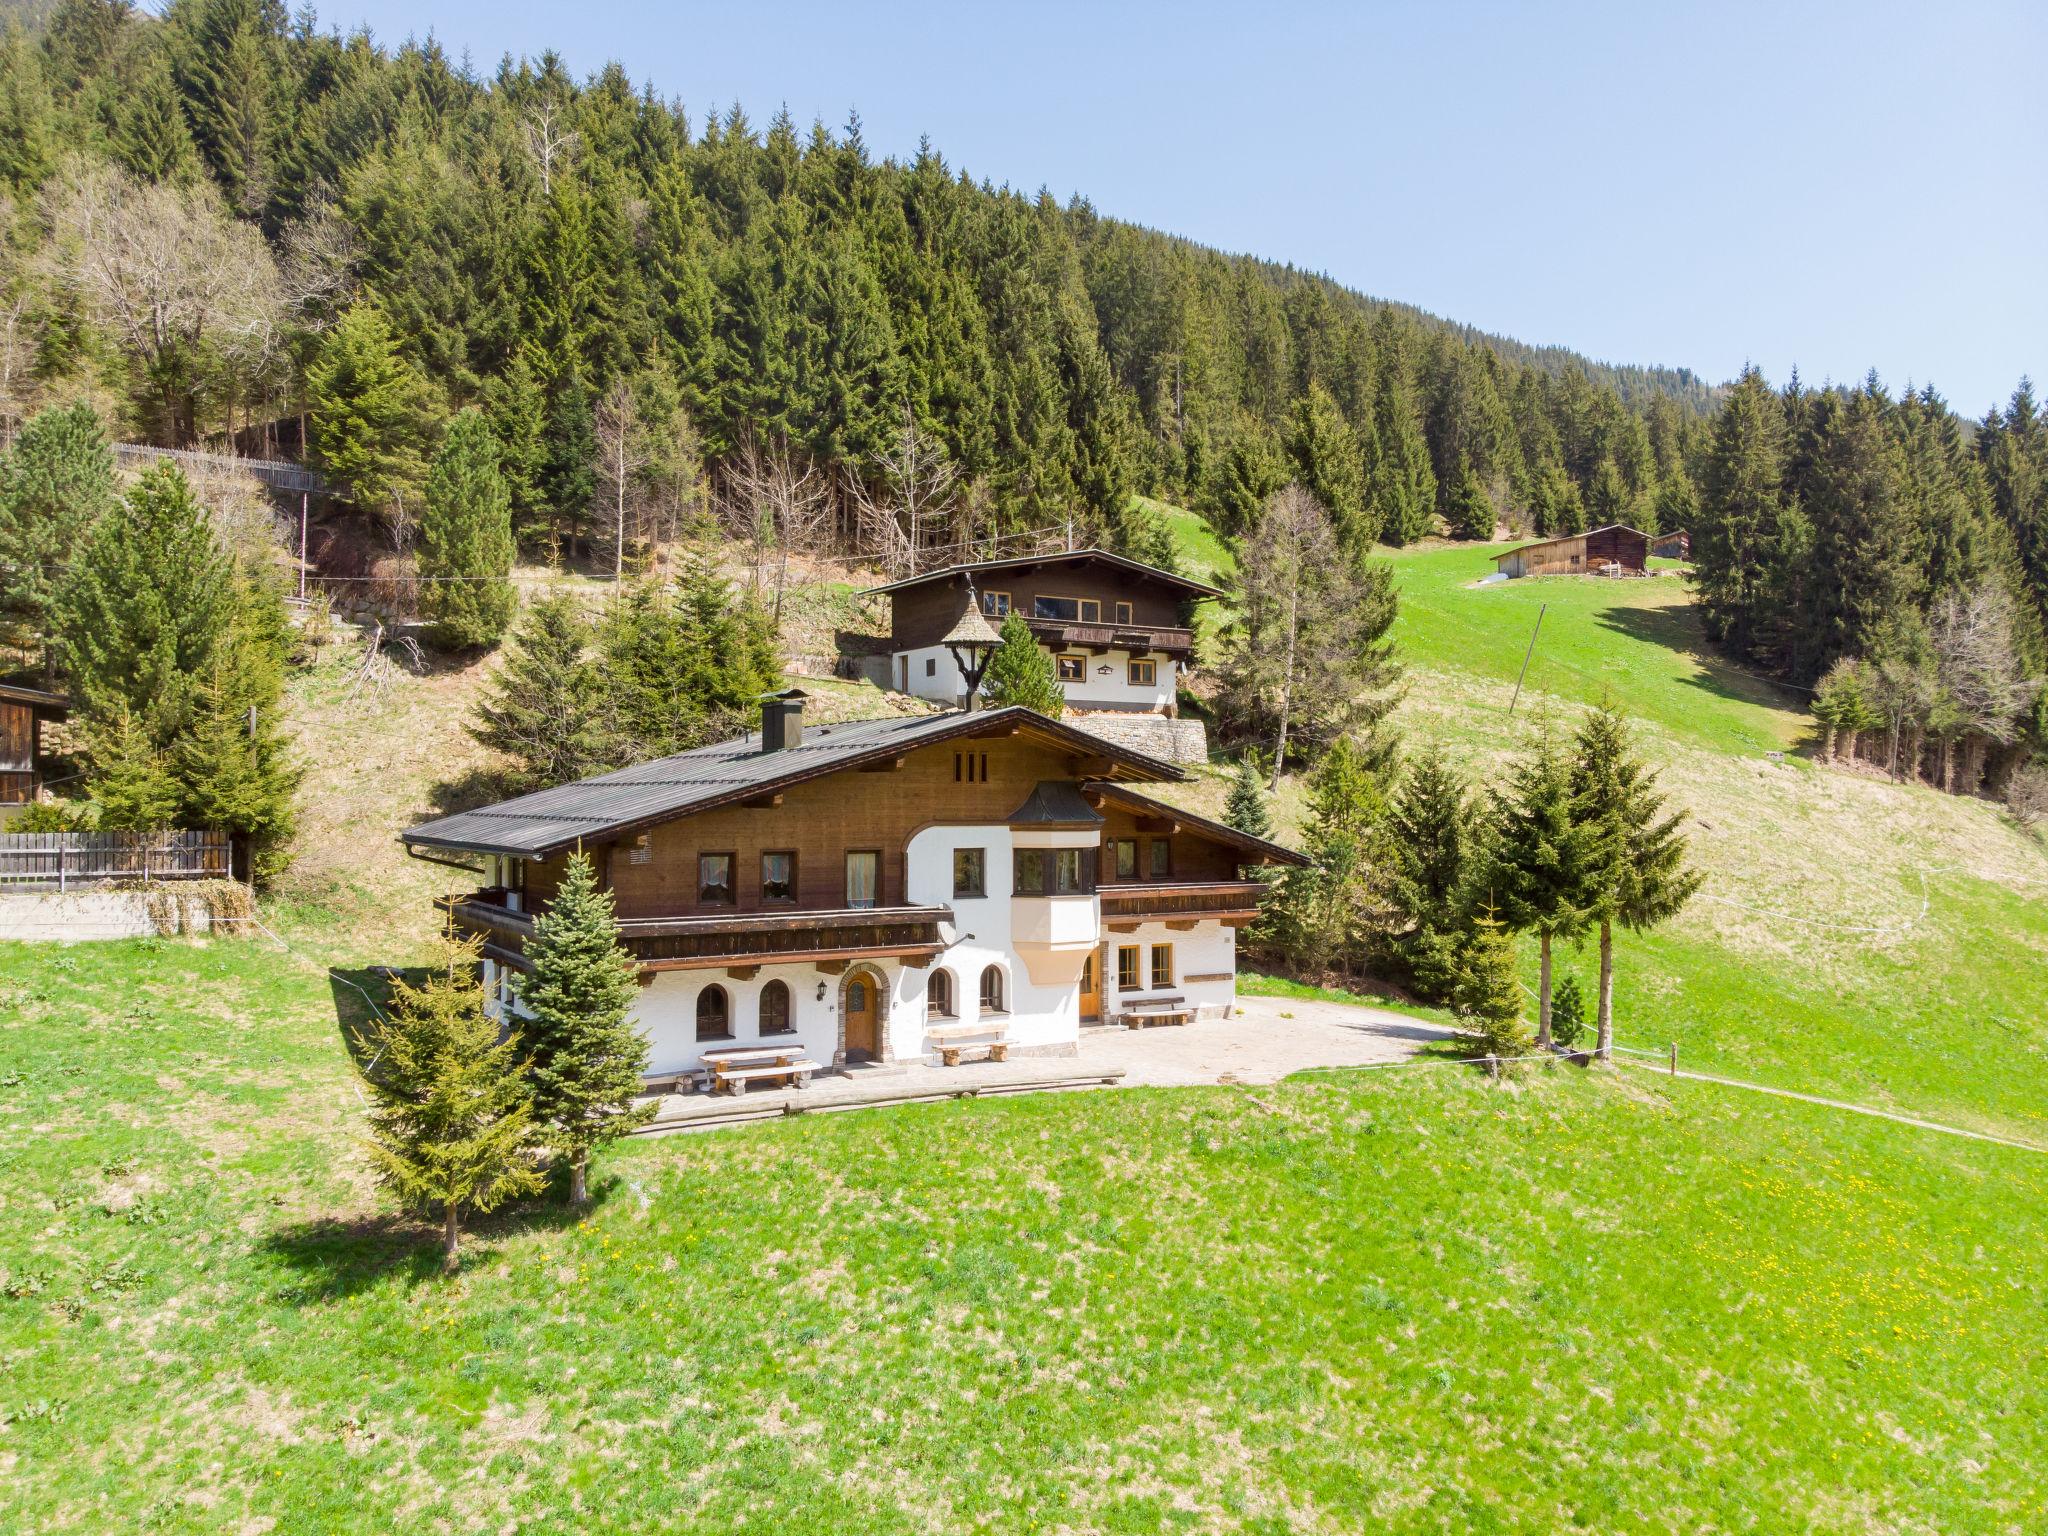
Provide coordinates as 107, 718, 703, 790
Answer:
45, 166, 287, 442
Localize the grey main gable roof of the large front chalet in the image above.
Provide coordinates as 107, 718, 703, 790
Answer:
399, 705, 1184, 858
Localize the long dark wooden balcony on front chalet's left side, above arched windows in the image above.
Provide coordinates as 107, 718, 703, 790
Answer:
436, 891, 952, 971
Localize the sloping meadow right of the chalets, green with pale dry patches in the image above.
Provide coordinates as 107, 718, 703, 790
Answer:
1155, 528, 2048, 1143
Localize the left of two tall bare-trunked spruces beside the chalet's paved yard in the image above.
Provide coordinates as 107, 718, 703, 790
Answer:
1487, 723, 1593, 1047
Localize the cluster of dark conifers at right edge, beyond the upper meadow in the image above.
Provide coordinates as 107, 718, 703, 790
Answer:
1692, 369, 2048, 793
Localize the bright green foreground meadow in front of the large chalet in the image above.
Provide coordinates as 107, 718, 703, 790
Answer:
0, 942, 2048, 1532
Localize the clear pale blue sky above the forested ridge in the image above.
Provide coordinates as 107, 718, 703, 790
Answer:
322, 0, 2048, 416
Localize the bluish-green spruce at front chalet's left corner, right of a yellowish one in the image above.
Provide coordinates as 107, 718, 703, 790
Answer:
518, 854, 655, 1204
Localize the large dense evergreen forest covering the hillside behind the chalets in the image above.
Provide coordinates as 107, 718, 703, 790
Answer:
0, 0, 1710, 577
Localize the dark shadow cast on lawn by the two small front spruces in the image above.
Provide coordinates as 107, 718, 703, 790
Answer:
260, 1171, 625, 1307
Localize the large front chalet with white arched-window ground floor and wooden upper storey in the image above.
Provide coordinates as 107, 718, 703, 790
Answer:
403, 690, 1303, 1075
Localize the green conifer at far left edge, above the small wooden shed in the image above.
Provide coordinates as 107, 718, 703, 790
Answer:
0, 401, 119, 682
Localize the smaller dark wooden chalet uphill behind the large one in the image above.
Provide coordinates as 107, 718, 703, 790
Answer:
870, 549, 1223, 717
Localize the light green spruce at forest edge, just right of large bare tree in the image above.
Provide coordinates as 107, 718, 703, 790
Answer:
305, 299, 426, 520
